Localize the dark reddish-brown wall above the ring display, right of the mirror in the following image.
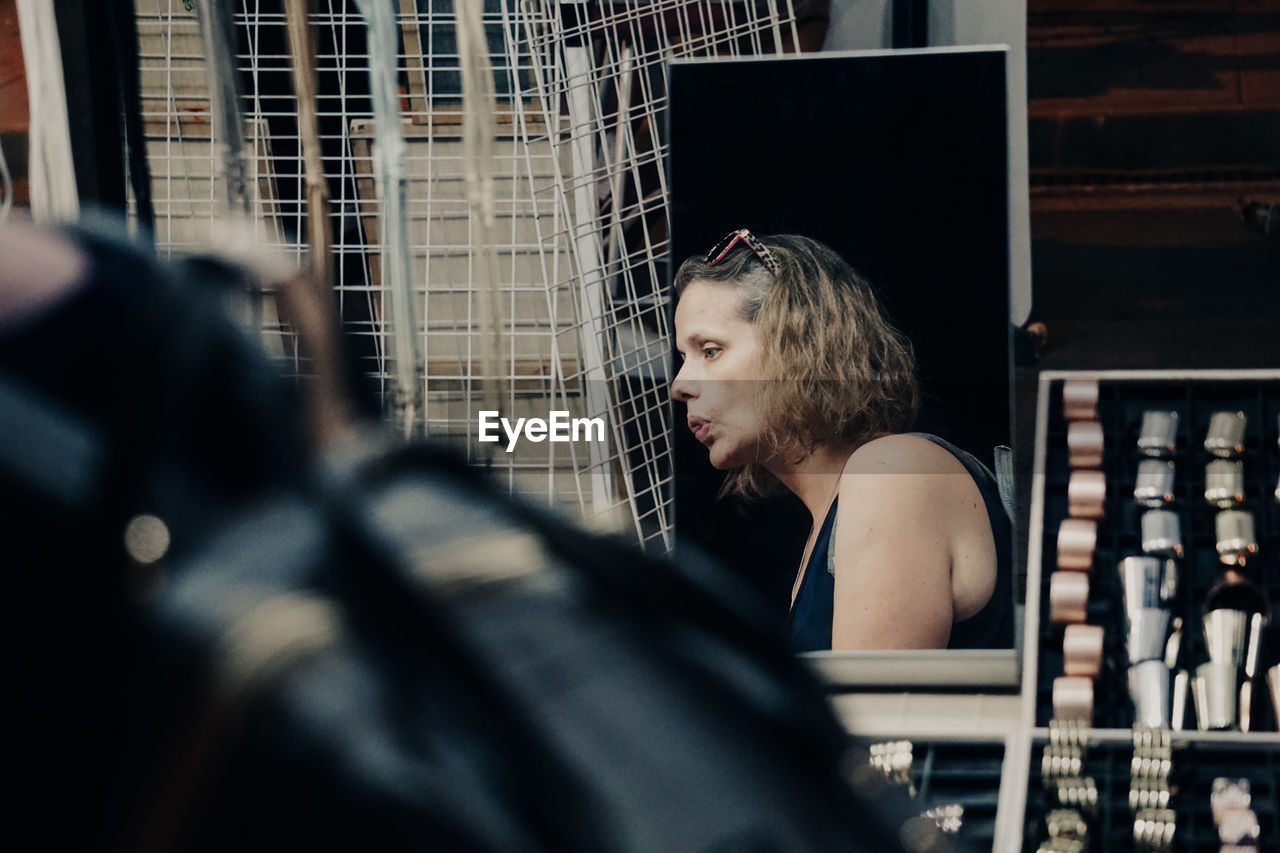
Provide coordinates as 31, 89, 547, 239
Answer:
1014, 0, 1280, 596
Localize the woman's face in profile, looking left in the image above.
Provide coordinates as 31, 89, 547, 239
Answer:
671, 279, 764, 470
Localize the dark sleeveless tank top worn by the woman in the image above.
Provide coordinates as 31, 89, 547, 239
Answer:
782, 433, 1014, 652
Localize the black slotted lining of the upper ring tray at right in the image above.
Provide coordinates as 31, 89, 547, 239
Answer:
1036, 378, 1280, 731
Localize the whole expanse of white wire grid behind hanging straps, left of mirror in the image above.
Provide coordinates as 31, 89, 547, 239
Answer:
136, 0, 796, 548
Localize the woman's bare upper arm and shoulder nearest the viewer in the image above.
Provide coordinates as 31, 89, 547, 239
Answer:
832, 435, 968, 649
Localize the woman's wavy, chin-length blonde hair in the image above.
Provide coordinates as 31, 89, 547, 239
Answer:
675, 234, 919, 497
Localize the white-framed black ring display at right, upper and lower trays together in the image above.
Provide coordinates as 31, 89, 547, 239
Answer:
1018, 370, 1280, 853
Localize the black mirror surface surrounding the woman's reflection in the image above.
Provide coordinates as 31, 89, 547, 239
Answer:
668, 51, 1011, 612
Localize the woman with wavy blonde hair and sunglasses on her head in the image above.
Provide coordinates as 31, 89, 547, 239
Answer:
672, 229, 1012, 652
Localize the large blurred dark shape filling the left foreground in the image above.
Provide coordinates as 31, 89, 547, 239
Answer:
0, 220, 945, 853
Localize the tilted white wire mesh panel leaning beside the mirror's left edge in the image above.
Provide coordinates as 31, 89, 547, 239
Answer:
502, 0, 795, 547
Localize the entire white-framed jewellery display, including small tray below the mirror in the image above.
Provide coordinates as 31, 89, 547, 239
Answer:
814, 370, 1280, 853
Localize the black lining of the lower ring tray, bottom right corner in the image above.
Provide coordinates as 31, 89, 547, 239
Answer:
1023, 733, 1280, 853
